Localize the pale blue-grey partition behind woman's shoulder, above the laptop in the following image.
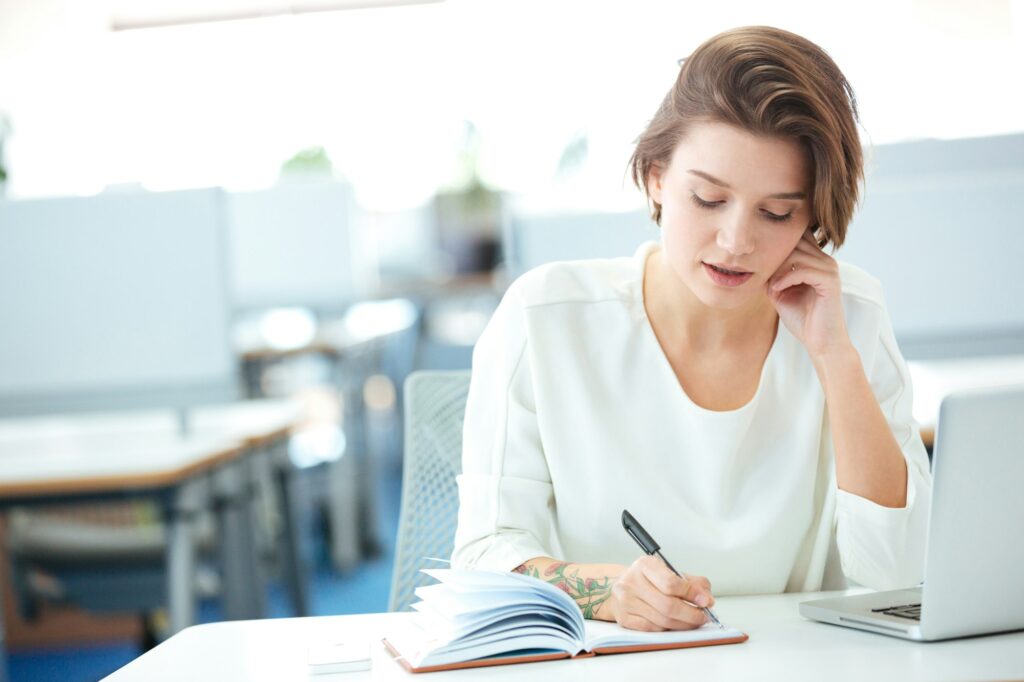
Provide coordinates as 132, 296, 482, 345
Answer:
837, 134, 1024, 358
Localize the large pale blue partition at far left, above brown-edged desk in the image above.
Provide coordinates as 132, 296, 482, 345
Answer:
0, 189, 238, 415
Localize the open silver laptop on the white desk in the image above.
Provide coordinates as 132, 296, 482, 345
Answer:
800, 385, 1024, 641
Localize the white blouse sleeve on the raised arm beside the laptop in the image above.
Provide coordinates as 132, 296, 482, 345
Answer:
829, 286, 932, 590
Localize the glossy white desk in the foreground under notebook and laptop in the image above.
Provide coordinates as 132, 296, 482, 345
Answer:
105, 591, 1024, 682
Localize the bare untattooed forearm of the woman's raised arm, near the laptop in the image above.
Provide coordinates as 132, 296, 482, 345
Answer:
814, 345, 907, 508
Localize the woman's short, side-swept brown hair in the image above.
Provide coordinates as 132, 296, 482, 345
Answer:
630, 26, 864, 248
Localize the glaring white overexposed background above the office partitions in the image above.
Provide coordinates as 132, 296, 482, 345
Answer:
0, 0, 1024, 210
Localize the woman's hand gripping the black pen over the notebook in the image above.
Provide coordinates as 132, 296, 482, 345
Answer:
602, 556, 715, 632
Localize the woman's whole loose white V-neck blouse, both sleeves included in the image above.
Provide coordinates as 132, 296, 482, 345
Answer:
452, 242, 931, 595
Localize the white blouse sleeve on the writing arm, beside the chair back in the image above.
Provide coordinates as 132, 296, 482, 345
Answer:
452, 283, 554, 570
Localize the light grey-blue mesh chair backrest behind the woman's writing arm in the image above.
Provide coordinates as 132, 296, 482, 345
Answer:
388, 370, 470, 611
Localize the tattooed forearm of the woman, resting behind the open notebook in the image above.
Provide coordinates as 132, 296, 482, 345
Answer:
513, 556, 626, 621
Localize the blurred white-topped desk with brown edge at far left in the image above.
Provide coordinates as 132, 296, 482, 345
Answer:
0, 400, 308, 667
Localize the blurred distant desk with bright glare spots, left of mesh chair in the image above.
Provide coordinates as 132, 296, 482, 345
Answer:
234, 298, 428, 571
